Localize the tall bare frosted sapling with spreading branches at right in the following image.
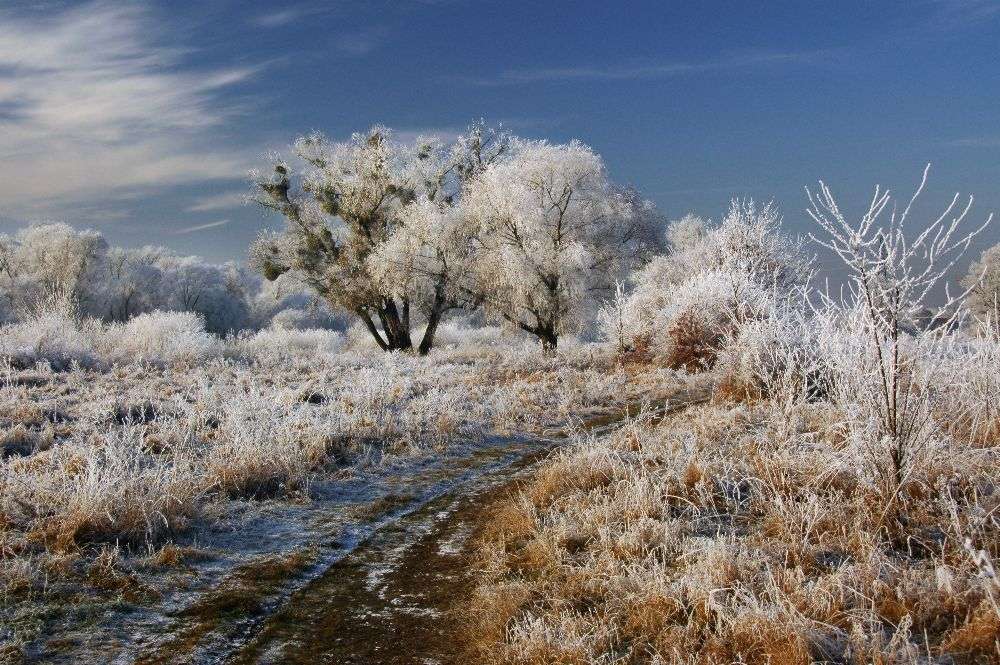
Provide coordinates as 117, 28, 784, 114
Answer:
807, 165, 992, 510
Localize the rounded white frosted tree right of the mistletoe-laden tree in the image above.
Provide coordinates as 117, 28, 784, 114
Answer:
463, 140, 655, 352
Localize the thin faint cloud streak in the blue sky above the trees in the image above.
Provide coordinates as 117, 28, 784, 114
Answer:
460, 51, 824, 86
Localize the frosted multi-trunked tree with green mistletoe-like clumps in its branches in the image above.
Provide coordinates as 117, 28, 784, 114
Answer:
251, 124, 509, 353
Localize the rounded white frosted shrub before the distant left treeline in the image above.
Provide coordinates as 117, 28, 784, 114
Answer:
105, 311, 222, 365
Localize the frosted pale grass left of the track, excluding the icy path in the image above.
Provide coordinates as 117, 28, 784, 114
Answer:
0, 313, 669, 608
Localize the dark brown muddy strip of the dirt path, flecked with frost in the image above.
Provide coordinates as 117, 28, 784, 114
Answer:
226, 395, 702, 665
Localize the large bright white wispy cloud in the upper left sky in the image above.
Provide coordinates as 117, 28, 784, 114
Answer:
0, 0, 258, 216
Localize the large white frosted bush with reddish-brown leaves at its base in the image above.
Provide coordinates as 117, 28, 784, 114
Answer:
602, 201, 809, 370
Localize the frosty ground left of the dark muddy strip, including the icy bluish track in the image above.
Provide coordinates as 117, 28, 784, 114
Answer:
0, 334, 677, 662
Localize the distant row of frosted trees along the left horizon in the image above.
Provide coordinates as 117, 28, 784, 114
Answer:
0, 224, 341, 335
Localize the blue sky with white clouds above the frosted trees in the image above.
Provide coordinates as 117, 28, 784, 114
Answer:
0, 0, 1000, 260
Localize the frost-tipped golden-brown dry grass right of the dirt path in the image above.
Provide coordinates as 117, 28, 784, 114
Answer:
469, 402, 1000, 664
